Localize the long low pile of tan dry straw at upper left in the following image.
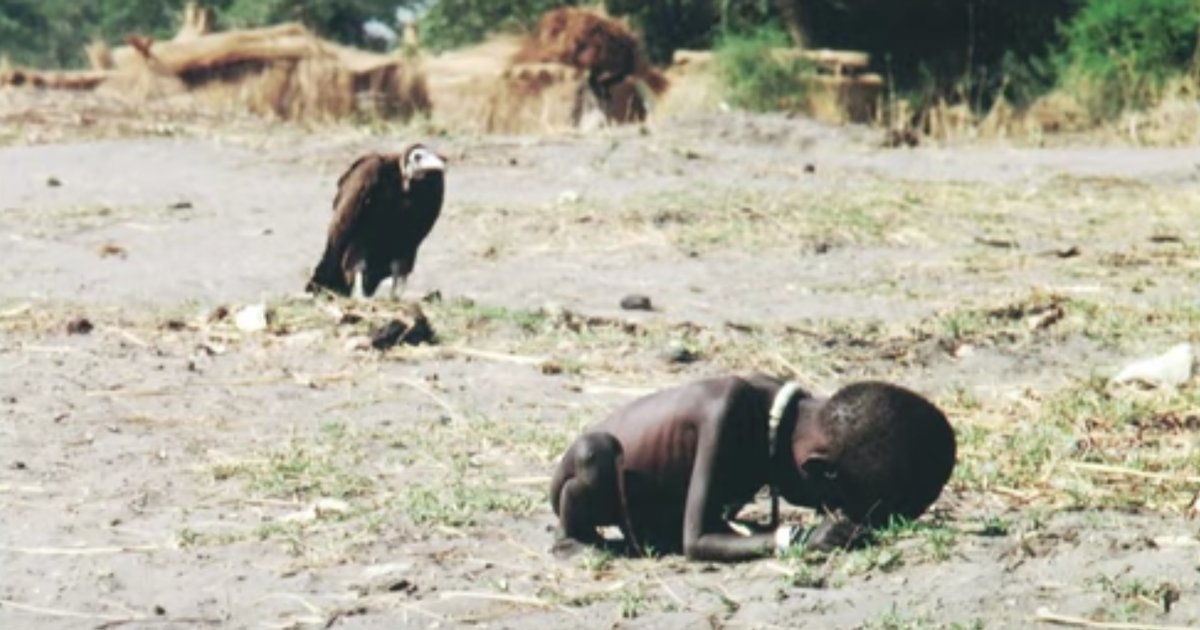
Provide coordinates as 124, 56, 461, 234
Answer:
0, 5, 432, 120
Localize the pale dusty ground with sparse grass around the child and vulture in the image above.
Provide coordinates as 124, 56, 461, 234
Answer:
0, 91, 1200, 629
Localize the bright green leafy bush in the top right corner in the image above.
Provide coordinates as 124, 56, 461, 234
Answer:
1060, 0, 1200, 116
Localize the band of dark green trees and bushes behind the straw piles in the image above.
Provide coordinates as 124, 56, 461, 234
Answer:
0, 0, 1200, 116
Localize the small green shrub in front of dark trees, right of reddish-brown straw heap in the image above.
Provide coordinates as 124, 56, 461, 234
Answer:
715, 28, 812, 110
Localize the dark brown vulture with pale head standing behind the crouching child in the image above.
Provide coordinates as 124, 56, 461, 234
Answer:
307, 144, 445, 298
